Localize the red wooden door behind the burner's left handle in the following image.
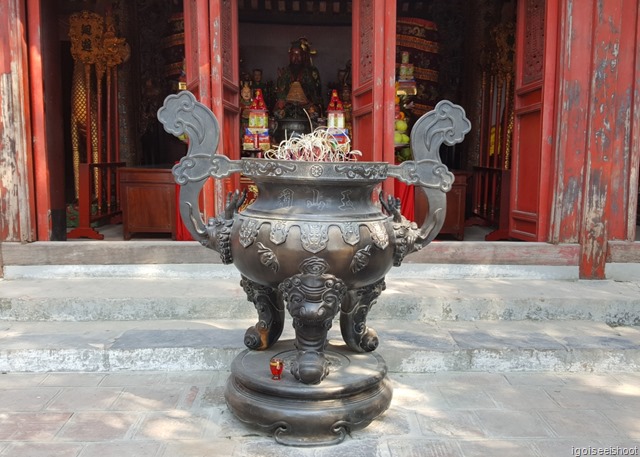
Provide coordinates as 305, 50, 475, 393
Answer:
184, 0, 240, 217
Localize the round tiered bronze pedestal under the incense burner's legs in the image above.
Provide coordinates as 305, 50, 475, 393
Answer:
225, 340, 392, 446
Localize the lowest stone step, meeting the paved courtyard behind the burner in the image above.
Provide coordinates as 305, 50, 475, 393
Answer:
0, 319, 640, 373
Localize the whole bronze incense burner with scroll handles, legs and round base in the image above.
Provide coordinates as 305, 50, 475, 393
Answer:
158, 92, 471, 446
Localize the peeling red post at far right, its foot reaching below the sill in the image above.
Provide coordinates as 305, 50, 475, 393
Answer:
580, 0, 638, 279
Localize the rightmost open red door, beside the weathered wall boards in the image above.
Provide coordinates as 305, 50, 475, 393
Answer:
509, 0, 558, 241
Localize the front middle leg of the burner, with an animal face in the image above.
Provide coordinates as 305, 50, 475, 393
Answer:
279, 257, 346, 384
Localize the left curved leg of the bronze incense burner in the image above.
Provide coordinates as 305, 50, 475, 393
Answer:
240, 276, 284, 350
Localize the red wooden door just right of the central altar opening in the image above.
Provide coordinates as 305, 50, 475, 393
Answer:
351, 0, 396, 174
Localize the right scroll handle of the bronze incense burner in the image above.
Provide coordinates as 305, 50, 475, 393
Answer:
388, 100, 471, 252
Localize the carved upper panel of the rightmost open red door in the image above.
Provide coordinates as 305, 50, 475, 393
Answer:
522, 0, 545, 84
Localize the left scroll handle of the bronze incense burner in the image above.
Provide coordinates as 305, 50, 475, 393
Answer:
158, 91, 242, 248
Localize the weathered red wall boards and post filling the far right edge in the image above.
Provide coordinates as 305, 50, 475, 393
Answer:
550, 0, 640, 279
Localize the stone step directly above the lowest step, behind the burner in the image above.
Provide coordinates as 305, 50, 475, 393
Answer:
0, 266, 640, 325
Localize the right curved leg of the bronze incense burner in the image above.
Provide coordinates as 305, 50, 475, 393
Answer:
340, 279, 386, 352
